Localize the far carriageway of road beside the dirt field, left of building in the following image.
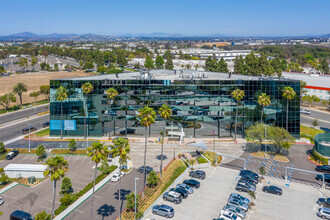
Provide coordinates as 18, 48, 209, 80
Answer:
0, 105, 49, 125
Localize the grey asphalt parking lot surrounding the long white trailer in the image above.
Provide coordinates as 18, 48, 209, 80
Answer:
0, 154, 98, 219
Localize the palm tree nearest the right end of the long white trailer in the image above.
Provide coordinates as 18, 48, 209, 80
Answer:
44, 155, 69, 219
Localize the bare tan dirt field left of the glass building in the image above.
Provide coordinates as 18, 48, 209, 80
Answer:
0, 71, 93, 105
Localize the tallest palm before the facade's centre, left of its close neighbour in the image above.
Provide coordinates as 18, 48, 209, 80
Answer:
137, 106, 156, 191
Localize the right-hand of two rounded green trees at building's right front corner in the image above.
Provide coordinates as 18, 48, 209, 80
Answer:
267, 127, 295, 153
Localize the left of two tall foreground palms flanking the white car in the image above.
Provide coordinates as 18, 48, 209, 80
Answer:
87, 141, 110, 220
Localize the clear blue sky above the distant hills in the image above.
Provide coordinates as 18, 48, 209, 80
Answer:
0, 0, 330, 36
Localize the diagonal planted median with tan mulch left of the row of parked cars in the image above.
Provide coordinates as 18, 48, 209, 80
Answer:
121, 159, 187, 220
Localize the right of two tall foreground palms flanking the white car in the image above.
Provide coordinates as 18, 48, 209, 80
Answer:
111, 137, 131, 219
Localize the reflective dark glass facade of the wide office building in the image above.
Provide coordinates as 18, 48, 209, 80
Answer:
50, 77, 300, 138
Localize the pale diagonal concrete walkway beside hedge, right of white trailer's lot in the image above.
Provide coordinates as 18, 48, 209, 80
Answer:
54, 168, 119, 220
